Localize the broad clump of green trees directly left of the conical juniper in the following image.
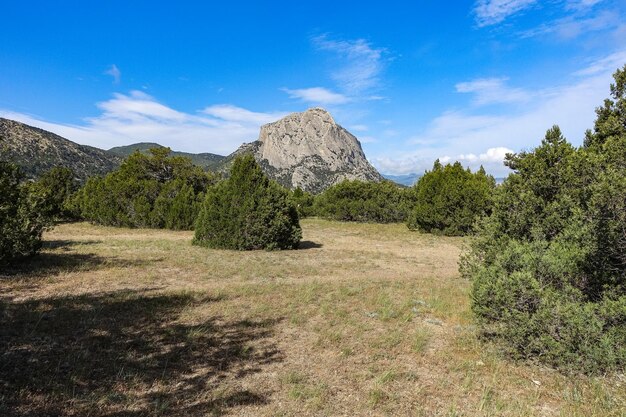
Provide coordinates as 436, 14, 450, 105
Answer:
73, 148, 215, 230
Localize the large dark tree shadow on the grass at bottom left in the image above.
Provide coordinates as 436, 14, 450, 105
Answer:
0, 291, 282, 416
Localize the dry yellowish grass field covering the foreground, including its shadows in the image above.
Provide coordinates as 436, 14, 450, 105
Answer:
0, 219, 626, 417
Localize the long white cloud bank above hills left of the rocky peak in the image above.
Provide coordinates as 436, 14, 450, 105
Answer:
0, 91, 286, 155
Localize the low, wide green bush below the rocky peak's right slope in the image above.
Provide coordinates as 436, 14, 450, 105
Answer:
313, 180, 410, 223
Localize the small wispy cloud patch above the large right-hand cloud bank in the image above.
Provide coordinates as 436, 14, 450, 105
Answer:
456, 78, 530, 105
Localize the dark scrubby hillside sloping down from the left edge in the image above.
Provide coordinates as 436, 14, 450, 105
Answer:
0, 118, 121, 181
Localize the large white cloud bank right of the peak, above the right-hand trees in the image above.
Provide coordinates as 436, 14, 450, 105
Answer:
373, 50, 626, 176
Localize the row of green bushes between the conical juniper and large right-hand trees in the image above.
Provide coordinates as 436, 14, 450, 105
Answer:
292, 161, 496, 236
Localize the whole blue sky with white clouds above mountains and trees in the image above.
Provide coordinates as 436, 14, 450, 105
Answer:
0, 0, 626, 176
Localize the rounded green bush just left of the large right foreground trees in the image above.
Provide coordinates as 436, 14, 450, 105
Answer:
407, 160, 495, 236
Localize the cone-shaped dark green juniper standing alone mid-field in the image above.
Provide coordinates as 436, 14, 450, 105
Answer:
194, 155, 302, 250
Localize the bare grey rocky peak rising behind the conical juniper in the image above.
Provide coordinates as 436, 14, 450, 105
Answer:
219, 108, 383, 193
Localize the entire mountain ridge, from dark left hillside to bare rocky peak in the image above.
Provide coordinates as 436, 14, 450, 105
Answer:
0, 108, 383, 193
